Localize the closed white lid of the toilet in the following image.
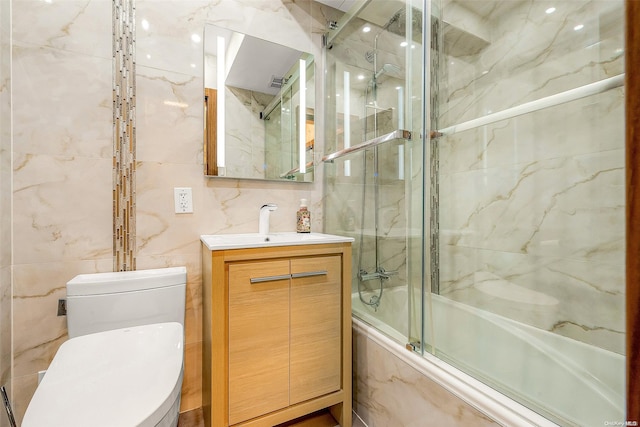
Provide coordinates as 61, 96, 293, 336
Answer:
22, 323, 184, 427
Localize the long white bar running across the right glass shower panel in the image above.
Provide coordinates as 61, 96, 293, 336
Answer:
436, 73, 624, 136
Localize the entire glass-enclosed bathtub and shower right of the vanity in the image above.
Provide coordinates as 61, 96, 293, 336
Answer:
323, 0, 625, 426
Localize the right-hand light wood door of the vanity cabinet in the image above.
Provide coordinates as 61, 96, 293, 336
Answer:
290, 256, 342, 405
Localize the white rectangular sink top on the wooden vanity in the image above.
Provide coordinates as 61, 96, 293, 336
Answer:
200, 232, 353, 251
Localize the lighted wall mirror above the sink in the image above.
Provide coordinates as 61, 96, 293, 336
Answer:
204, 24, 315, 182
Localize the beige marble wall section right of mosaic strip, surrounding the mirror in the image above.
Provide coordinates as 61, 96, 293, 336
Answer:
136, 0, 334, 410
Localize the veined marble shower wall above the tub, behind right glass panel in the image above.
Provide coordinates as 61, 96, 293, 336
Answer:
439, 0, 625, 353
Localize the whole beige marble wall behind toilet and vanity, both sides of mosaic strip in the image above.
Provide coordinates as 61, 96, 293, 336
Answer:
8, 0, 336, 420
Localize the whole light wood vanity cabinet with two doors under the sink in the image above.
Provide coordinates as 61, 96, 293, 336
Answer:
203, 243, 351, 427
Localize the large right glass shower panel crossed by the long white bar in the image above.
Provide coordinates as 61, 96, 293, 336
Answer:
425, 0, 625, 426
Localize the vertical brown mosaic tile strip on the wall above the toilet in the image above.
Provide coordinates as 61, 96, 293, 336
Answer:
113, 0, 136, 271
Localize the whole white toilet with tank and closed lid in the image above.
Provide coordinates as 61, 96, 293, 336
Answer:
22, 267, 187, 427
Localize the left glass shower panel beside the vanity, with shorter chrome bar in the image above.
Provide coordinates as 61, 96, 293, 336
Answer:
323, 0, 424, 345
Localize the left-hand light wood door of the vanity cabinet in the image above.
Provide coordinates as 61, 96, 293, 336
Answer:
229, 260, 290, 424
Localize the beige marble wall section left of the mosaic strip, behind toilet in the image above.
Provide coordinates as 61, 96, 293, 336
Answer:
12, 0, 113, 422
